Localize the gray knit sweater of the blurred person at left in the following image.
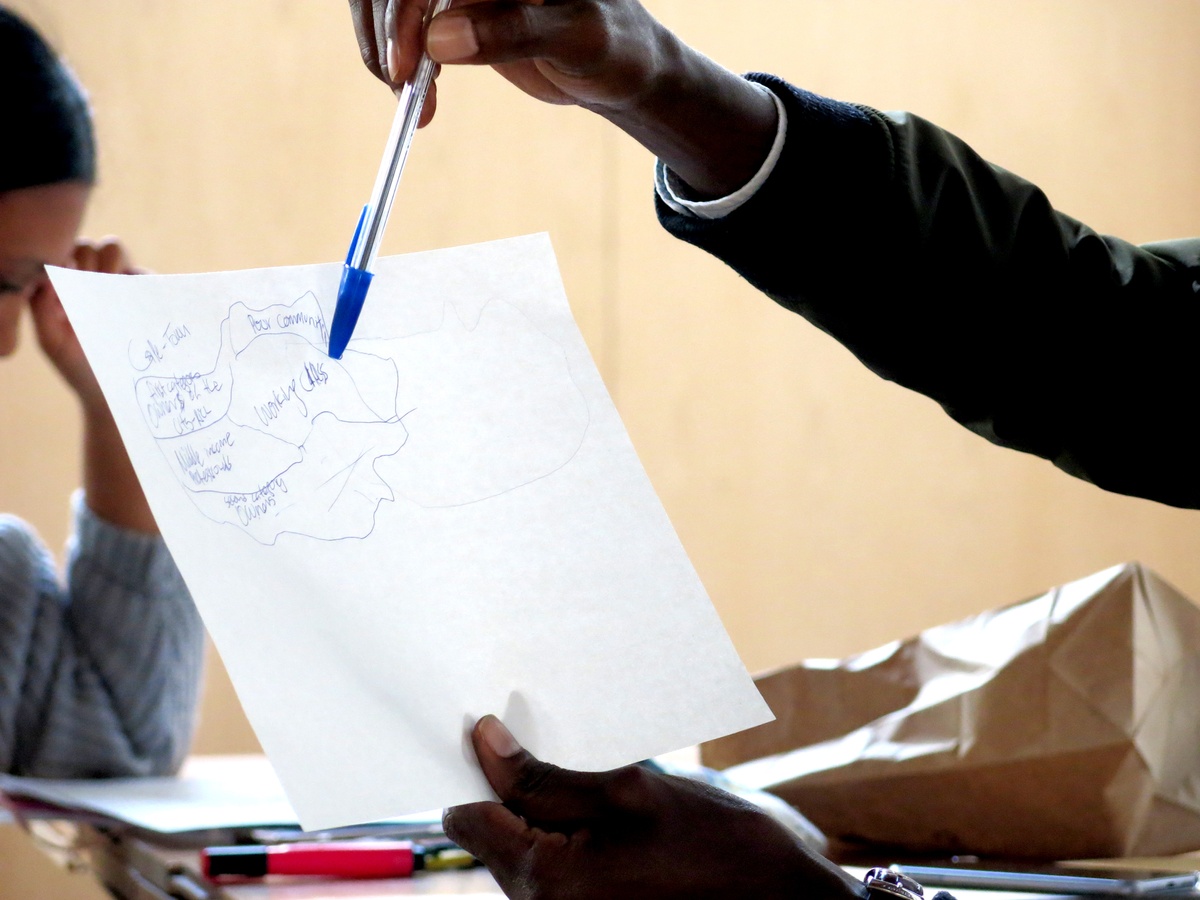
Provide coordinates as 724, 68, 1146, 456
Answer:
0, 493, 204, 778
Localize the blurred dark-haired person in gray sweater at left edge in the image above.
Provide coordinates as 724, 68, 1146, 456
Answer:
0, 7, 204, 778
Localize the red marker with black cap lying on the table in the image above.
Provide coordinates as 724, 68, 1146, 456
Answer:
200, 840, 474, 878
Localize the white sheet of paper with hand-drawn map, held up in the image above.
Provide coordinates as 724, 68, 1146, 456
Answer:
52, 235, 770, 828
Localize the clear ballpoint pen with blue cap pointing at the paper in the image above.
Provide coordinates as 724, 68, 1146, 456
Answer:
329, 0, 450, 359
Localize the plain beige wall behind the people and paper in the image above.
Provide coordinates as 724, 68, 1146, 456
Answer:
0, 0, 1200, 898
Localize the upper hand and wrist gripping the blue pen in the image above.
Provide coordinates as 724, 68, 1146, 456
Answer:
349, 0, 776, 198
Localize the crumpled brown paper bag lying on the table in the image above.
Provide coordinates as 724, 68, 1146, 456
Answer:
701, 563, 1200, 859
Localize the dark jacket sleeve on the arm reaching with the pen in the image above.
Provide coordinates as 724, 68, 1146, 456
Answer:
658, 76, 1200, 508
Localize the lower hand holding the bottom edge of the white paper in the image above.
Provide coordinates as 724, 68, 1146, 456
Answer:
443, 716, 859, 900
